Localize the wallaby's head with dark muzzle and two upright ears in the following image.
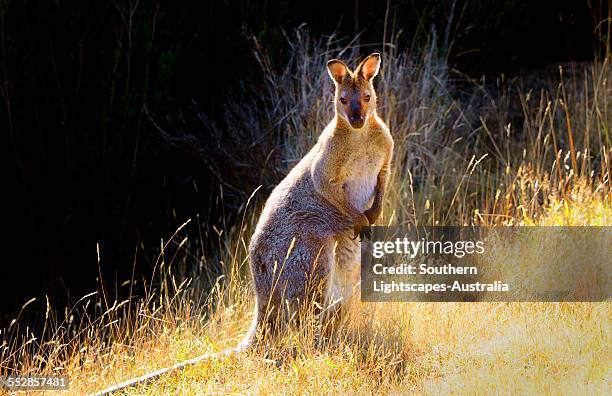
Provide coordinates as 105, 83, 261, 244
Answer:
327, 52, 380, 129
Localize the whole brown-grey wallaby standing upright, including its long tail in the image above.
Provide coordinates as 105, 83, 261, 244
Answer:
93, 53, 393, 394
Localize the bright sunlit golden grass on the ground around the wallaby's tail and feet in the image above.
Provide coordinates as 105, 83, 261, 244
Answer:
0, 184, 612, 395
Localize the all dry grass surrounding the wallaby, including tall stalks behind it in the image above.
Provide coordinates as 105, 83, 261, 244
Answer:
0, 31, 612, 394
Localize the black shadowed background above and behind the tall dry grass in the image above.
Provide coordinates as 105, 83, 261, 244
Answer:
0, 0, 608, 325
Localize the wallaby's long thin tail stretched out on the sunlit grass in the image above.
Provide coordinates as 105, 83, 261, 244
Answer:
94, 308, 259, 396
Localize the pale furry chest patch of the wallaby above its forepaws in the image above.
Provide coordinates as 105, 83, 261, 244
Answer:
345, 147, 384, 212
